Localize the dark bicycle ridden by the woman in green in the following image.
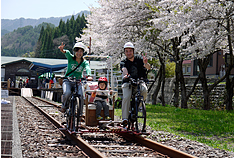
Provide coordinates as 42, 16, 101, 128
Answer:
64, 77, 83, 133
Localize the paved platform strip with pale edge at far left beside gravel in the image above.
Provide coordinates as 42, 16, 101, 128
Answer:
1, 96, 23, 158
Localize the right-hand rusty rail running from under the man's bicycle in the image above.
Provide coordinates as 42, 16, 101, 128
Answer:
118, 133, 197, 158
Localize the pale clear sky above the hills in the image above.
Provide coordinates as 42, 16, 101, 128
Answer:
1, 0, 100, 19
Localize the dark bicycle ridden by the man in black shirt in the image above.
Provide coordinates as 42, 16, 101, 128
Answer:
127, 78, 146, 133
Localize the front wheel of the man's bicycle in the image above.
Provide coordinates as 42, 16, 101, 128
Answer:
136, 100, 146, 133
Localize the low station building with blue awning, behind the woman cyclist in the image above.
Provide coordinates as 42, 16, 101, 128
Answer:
1, 56, 107, 88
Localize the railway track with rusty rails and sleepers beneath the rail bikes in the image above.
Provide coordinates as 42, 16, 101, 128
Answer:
18, 97, 197, 158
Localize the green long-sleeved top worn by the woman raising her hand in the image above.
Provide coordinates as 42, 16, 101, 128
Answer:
65, 50, 91, 79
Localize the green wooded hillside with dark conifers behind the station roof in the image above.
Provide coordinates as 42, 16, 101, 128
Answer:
1, 14, 87, 59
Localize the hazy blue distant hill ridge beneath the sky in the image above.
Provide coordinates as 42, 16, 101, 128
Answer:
1, 10, 89, 33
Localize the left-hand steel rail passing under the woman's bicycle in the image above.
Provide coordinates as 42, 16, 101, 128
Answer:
23, 97, 106, 158
